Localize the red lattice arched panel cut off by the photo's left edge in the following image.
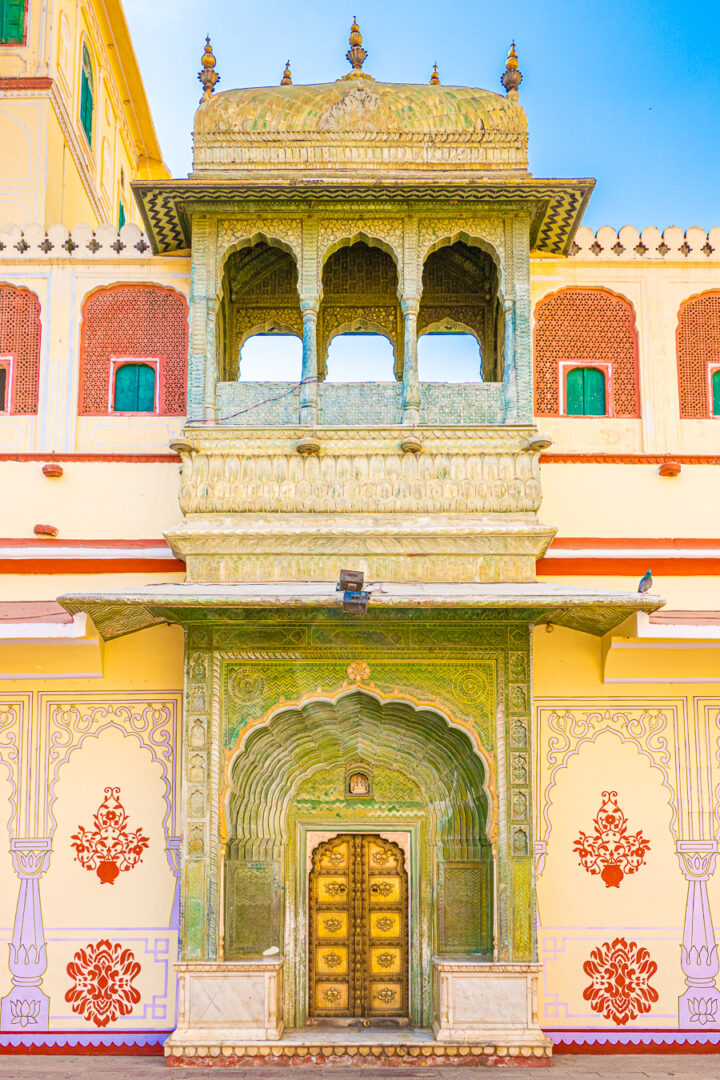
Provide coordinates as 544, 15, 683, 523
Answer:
0, 283, 41, 416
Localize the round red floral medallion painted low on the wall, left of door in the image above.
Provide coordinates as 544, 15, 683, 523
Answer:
65, 939, 140, 1027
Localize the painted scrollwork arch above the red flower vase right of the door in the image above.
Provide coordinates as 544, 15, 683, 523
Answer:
536, 706, 679, 874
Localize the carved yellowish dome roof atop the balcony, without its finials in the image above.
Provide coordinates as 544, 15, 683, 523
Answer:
194, 76, 527, 178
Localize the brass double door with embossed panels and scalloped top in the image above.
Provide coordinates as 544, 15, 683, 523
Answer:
309, 834, 408, 1020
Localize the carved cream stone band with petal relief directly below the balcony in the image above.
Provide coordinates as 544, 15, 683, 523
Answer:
173, 426, 541, 514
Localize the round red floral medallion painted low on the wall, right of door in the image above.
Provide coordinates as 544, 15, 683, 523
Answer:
583, 937, 657, 1024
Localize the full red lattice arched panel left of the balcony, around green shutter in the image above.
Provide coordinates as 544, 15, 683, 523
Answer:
78, 284, 188, 416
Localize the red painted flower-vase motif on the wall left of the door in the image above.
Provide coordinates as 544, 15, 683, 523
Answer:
71, 787, 149, 885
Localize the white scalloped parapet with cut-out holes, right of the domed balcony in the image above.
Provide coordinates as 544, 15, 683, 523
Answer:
570, 225, 720, 262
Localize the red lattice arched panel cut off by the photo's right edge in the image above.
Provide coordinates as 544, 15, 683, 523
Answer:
676, 291, 720, 420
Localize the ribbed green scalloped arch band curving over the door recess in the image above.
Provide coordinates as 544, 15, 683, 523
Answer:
223, 687, 497, 858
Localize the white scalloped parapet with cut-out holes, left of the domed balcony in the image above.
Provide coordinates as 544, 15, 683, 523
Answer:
0, 222, 152, 259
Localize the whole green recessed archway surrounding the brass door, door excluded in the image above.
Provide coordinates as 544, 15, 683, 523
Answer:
225, 690, 493, 1026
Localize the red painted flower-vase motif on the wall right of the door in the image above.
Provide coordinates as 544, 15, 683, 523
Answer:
573, 792, 650, 889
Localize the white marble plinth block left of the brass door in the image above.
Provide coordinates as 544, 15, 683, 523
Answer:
165, 957, 285, 1048
